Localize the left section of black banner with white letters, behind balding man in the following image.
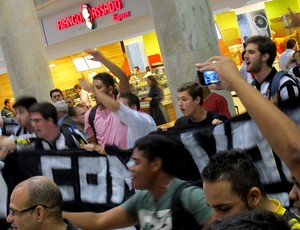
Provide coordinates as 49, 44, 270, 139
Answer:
0, 149, 134, 229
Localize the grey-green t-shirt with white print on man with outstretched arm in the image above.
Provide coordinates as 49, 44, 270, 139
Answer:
122, 179, 213, 230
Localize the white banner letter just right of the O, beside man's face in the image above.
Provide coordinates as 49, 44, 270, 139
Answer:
107, 155, 132, 204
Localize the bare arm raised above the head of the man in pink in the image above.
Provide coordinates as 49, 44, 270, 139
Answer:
85, 49, 131, 94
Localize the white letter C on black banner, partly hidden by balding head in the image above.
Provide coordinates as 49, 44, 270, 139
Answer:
41, 155, 75, 201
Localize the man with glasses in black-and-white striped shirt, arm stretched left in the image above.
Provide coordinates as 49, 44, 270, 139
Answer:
0, 102, 86, 151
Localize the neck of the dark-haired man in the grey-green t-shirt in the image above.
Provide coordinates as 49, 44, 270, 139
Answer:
149, 174, 174, 201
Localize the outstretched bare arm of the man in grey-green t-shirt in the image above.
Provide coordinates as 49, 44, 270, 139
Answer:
63, 206, 137, 230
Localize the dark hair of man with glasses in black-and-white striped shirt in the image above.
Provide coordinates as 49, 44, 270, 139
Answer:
28, 102, 57, 124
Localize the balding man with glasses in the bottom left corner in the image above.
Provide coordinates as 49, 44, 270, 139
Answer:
6, 176, 77, 230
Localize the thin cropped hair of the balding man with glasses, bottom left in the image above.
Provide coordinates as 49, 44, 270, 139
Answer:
27, 179, 63, 219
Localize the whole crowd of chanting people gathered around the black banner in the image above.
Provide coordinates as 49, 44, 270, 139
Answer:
0, 33, 300, 230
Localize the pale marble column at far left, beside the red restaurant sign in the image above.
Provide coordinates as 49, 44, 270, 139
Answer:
0, 0, 54, 101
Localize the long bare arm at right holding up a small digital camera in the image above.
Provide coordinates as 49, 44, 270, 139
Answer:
196, 56, 300, 182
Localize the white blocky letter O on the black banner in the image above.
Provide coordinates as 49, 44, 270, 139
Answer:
78, 157, 108, 204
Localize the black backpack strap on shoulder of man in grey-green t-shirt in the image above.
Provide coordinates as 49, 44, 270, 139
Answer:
171, 182, 201, 230
